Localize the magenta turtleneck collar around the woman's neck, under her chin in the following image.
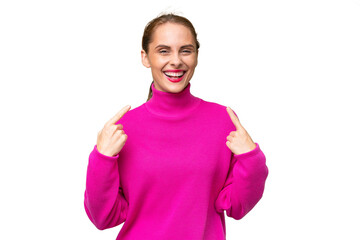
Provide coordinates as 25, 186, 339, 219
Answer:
145, 82, 201, 118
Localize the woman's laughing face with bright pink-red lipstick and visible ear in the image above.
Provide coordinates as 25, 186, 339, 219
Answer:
141, 22, 198, 93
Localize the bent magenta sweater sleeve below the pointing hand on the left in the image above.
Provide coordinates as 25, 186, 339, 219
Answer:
84, 145, 129, 230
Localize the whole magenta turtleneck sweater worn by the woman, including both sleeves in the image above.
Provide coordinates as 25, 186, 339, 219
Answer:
84, 83, 268, 240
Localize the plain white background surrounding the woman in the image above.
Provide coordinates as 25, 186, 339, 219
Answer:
0, 0, 360, 240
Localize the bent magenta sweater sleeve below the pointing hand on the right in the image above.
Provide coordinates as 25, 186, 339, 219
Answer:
215, 143, 268, 220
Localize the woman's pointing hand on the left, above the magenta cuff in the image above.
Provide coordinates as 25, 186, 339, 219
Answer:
97, 105, 131, 157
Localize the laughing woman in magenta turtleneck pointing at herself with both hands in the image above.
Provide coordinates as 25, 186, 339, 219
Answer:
85, 14, 268, 240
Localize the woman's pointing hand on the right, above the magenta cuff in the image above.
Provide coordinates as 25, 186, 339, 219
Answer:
226, 107, 256, 155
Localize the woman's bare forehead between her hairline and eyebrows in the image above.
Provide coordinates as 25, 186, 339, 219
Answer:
151, 22, 194, 46
